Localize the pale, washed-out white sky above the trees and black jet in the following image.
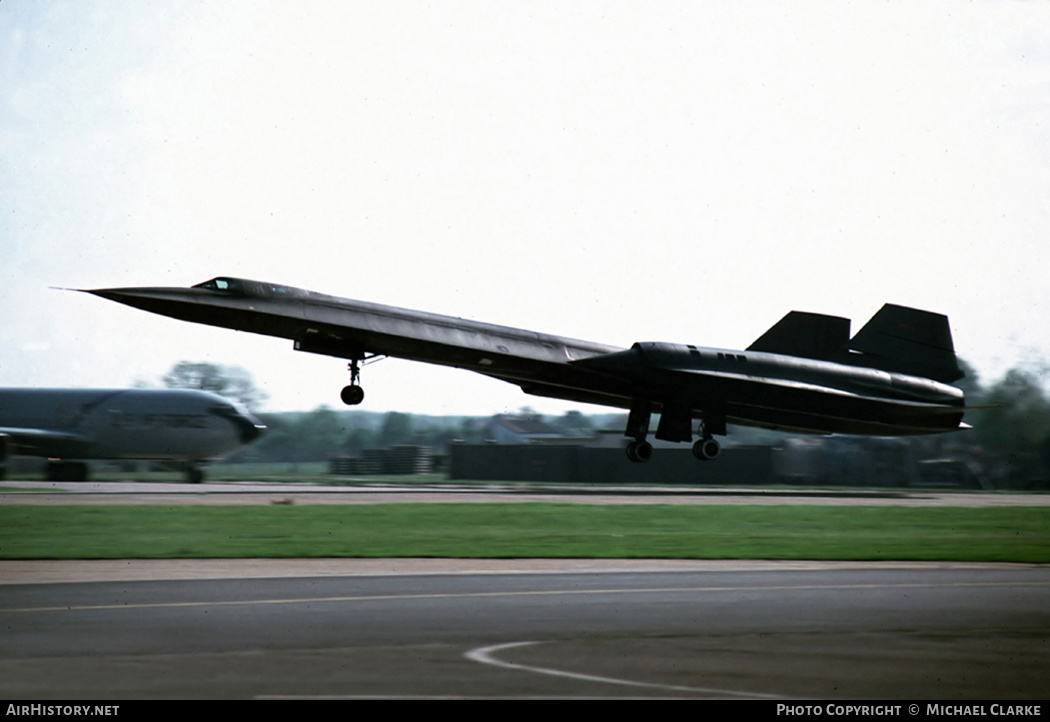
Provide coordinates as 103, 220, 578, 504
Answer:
0, 0, 1050, 413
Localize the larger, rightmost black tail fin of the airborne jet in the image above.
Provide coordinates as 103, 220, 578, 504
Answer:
849, 303, 965, 383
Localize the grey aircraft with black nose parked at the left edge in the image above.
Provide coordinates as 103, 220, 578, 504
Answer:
0, 388, 265, 482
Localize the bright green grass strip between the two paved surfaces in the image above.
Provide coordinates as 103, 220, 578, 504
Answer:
0, 504, 1050, 562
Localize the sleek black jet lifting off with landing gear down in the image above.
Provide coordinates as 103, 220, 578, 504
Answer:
85, 277, 967, 462
